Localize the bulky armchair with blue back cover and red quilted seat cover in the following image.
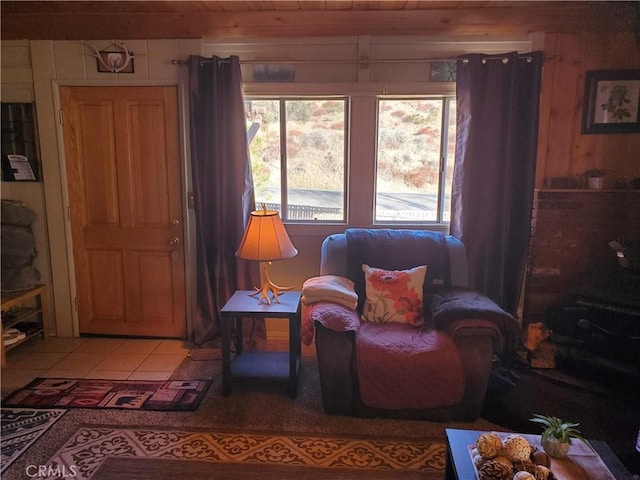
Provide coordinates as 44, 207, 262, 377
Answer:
305, 229, 518, 421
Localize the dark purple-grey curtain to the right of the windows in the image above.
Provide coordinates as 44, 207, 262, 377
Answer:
451, 52, 543, 314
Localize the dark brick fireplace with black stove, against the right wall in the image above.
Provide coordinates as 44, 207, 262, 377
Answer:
523, 189, 640, 384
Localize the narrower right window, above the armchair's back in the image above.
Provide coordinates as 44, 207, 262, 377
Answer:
374, 97, 456, 223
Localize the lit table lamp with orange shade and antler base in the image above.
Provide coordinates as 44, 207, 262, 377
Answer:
236, 203, 298, 305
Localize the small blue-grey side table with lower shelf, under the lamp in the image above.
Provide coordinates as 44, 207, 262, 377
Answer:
220, 290, 302, 398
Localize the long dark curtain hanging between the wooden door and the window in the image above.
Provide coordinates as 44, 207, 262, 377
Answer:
189, 56, 265, 348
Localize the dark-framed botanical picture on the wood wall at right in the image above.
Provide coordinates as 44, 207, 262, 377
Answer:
582, 70, 640, 134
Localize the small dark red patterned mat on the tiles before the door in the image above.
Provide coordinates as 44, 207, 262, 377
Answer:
4, 378, 211, 411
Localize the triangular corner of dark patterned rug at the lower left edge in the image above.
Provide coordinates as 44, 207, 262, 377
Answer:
0, 408, 66, 473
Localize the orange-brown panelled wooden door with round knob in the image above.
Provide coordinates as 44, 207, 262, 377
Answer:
60, 87, 186, 338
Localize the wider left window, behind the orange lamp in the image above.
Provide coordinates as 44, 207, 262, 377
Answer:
246, 97, 348, 222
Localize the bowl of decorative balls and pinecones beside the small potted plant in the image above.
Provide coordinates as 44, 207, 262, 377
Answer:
469, 432, 557, 480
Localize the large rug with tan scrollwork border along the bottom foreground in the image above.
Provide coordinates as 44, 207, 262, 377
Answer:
47, 426, 446, 480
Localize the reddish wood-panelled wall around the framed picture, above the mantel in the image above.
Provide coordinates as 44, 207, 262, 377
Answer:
536, 33, 640, 188
